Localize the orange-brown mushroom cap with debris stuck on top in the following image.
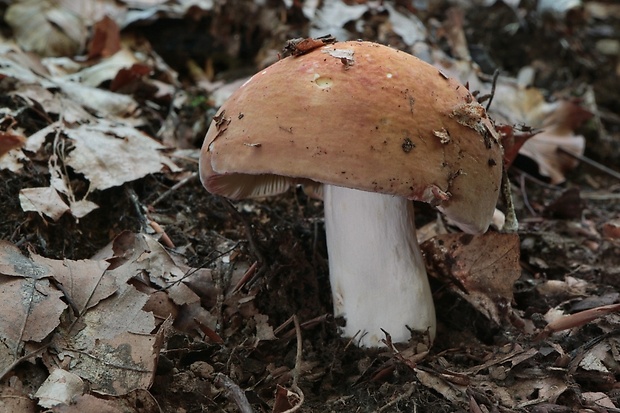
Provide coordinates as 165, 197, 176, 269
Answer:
200, 41, 502, 232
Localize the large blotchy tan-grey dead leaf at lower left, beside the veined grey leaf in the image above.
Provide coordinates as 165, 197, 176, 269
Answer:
53, 266, 161, 395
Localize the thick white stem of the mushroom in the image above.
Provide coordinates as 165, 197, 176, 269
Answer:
323, 185, 436, 347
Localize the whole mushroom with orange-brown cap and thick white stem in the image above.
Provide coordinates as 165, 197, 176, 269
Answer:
200, 41, 502, 347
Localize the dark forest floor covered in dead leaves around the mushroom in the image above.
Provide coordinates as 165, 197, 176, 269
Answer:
0, 0, 620, 413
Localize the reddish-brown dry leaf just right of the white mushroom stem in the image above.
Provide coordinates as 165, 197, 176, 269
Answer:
421, 232, 521, 324
